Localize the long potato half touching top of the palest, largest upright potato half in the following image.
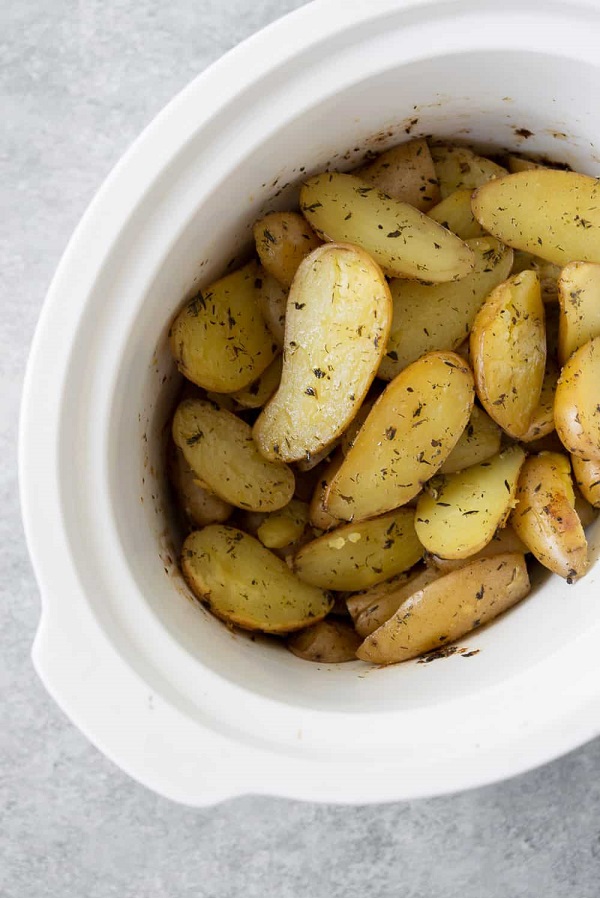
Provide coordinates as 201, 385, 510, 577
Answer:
300, 172, 473, 283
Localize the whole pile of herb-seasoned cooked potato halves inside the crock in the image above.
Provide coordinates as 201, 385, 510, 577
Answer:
169, 140, 600, 664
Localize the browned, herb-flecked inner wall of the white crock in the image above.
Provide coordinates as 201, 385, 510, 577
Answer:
110, 52, 600, 711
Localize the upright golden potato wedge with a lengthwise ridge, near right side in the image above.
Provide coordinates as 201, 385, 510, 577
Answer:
471, 271, 546, 438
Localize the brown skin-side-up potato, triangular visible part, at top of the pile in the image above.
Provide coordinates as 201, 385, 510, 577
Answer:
354, 140, 440, 212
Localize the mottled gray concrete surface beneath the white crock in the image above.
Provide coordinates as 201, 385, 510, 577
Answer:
0, 0, 600, 898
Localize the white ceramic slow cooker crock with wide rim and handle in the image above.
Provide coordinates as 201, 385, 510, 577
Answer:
21, 0, 600, 805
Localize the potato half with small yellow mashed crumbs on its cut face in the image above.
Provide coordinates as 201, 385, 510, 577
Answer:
293, 508, 423, 590
